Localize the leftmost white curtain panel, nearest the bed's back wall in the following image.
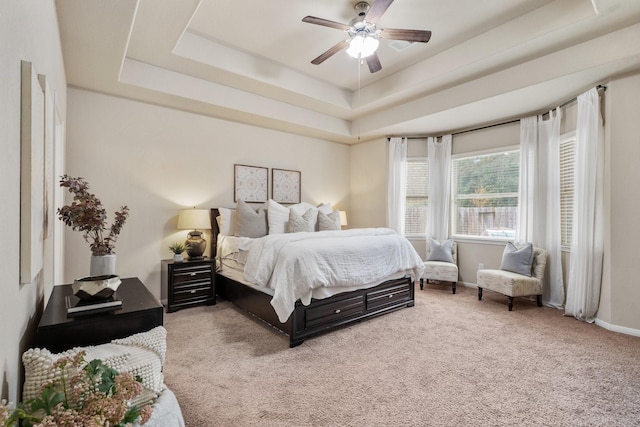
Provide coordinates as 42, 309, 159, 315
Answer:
387, 138, 407, 234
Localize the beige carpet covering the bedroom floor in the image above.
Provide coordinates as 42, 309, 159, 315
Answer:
165, 285, 640, 426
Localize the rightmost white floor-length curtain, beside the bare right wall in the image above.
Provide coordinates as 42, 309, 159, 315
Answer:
565, 88, 604, 323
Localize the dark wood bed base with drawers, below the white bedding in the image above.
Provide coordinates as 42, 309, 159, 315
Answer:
216, 274, 415, 347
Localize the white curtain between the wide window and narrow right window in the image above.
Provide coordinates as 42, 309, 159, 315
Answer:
516, 108, 564, 308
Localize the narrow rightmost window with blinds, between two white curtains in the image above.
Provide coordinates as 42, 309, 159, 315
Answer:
560, 134, 576, 249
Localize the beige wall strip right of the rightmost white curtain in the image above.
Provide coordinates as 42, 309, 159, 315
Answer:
598, 74, 640, 334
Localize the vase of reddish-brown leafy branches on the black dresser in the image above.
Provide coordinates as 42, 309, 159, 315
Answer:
58, 174, 129, 276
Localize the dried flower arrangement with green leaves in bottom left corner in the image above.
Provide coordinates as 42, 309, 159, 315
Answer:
0, 351, 151, 427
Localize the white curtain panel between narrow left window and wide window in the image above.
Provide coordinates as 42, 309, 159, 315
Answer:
425, 135, 451, 241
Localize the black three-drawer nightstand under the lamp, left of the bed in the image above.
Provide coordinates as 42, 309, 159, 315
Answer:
162, 258, 216, 313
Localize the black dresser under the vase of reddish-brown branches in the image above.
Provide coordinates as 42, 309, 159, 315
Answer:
36, 277, 163, 353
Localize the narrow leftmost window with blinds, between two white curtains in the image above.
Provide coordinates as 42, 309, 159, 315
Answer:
404, 157, 429, 236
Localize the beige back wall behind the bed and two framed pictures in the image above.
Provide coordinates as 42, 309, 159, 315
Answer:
65, 89, 350, 298
